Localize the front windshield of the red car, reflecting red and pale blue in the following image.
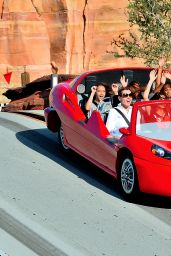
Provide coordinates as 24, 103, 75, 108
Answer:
136, 101, 171, 141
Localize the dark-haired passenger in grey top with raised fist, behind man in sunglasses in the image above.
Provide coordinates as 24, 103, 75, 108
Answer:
85, 83, 112, 121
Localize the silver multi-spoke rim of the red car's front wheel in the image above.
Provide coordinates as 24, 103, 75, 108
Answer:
121, 159, 135, 194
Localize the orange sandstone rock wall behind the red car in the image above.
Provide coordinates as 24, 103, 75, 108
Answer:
0, 0, 144, 101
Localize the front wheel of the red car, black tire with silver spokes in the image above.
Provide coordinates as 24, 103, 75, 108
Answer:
118, 154, 140, 202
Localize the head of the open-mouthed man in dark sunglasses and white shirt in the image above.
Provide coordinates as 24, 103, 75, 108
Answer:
118, 86, 133, 109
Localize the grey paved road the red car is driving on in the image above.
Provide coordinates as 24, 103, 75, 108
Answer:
0, 113, 171, 256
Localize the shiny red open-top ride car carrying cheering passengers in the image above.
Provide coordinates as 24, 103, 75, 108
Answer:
44, 68, 171, 200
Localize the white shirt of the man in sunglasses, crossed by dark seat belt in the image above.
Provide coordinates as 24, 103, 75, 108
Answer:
106, 104, 132, 137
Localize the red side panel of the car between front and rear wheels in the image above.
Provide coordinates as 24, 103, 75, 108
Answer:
56, 84, 116, 176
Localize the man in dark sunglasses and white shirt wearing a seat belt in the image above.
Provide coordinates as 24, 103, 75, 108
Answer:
106, 87, 133, 140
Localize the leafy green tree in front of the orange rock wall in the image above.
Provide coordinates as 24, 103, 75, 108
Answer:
112, 0, 171, 65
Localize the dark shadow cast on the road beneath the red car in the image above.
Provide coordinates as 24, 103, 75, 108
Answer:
16, 128, 171, 209
